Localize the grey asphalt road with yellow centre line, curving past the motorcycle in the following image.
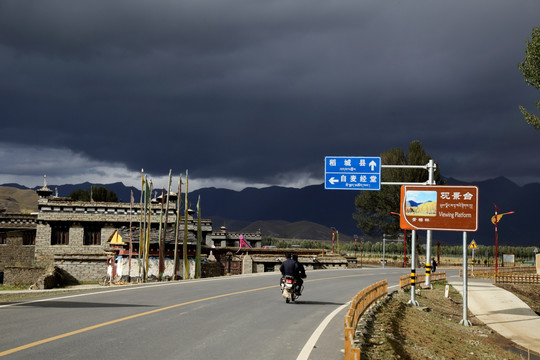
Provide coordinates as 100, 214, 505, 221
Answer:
0, 268, 410, 360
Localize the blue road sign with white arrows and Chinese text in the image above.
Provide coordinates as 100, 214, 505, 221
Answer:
324, 156, 381, 190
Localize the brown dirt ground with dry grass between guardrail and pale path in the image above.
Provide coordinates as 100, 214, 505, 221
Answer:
361, 283, 540, 360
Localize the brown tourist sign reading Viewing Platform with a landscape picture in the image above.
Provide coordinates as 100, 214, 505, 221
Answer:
399, 185, 478, 231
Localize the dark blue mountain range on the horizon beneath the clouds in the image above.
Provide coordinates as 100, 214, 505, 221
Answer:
0, 177, 540, 246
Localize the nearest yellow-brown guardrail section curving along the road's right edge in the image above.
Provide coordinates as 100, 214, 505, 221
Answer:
344, 280, 388, 360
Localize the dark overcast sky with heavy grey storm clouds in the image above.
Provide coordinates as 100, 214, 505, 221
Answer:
0, 0, 540, 190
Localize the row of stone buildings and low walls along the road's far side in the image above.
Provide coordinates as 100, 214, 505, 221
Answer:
0, 184, 355, 284
